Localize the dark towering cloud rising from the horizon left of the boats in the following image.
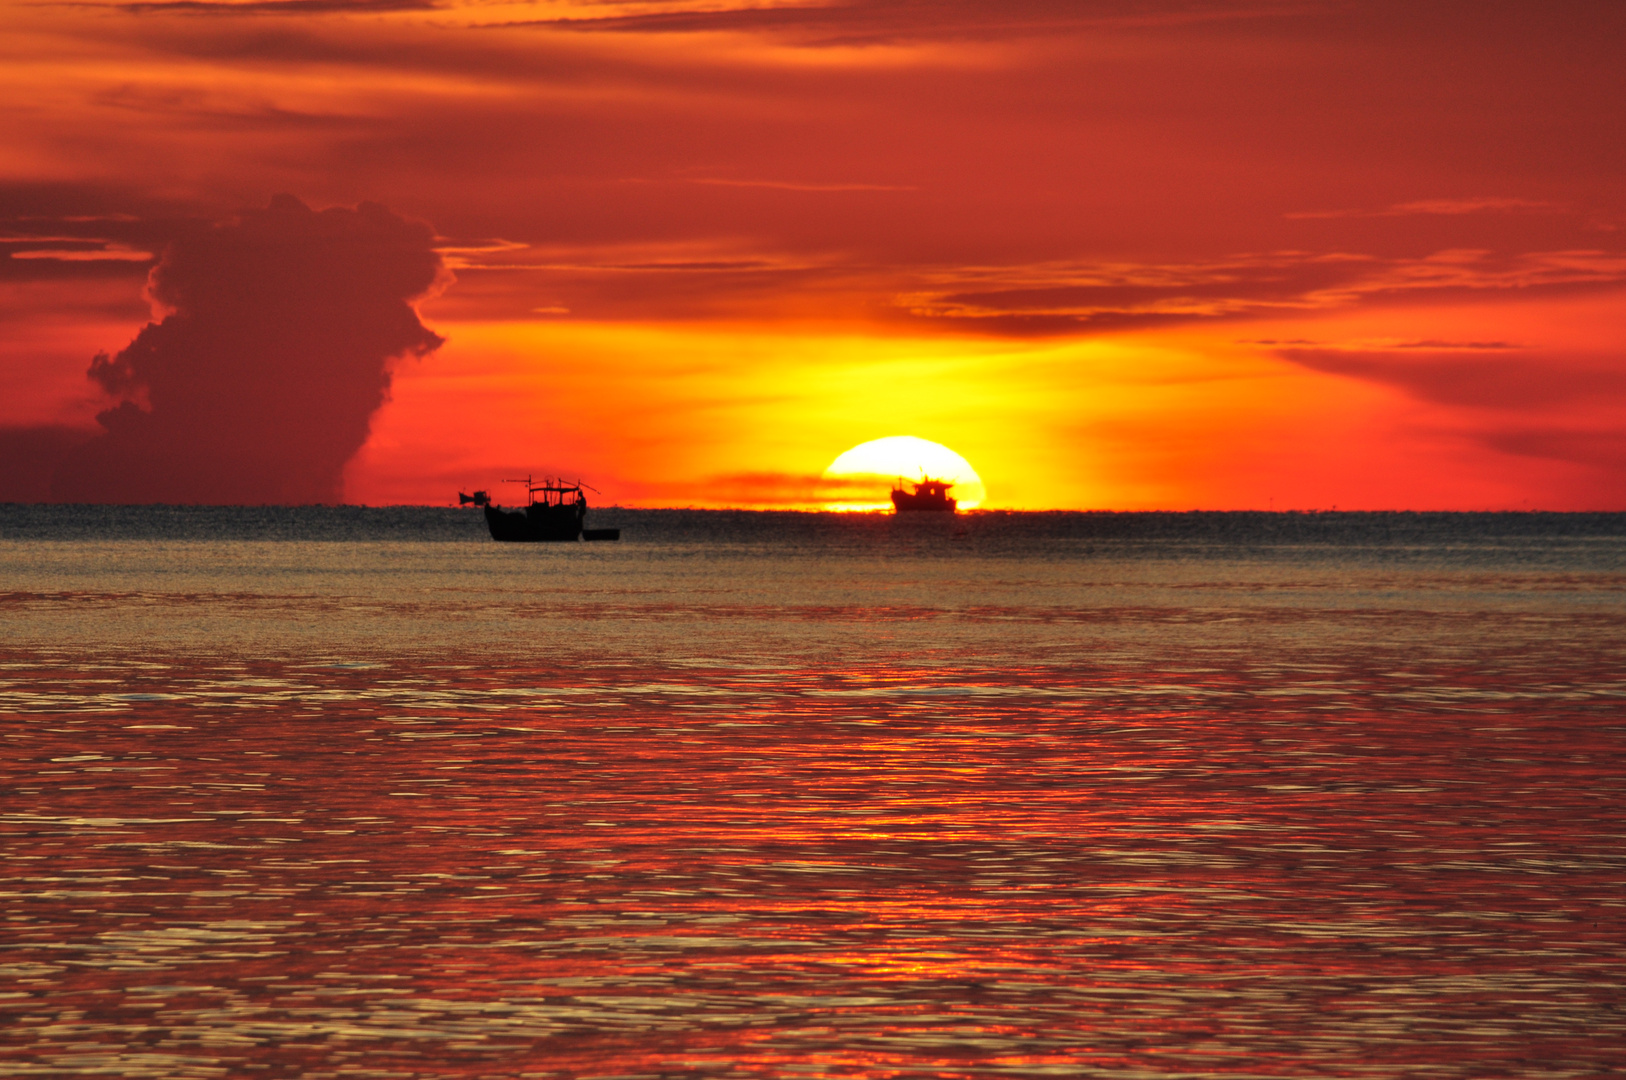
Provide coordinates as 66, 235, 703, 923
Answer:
52, 195, 446, 503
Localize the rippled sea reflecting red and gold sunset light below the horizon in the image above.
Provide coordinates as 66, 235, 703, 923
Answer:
0, 506, 1626, 1078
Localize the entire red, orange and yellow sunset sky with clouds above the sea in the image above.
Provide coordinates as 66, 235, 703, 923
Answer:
0, 0, 1626, 511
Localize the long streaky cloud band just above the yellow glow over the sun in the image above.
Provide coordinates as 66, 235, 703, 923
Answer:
422, 242, 1626, 337
